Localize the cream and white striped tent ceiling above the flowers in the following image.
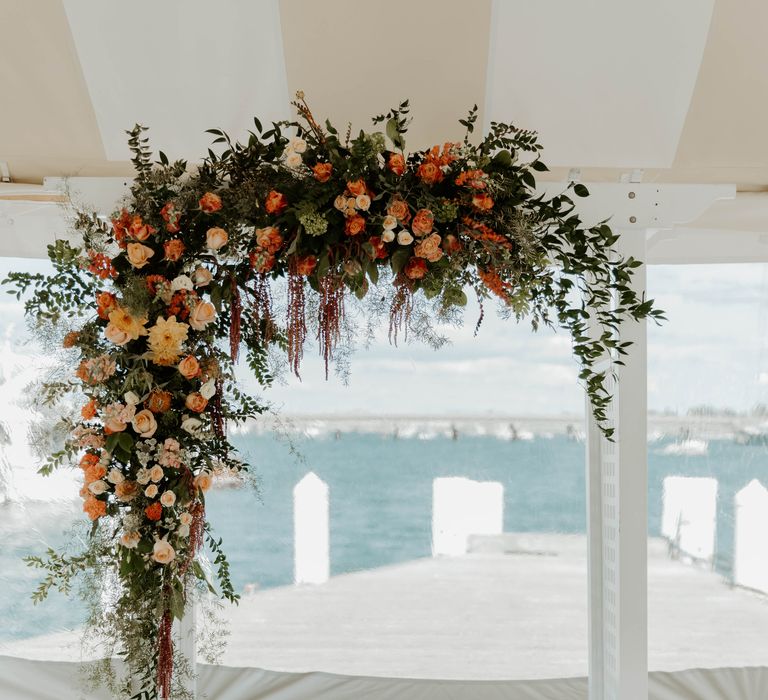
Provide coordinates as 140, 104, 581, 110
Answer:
0, 0, 768, 190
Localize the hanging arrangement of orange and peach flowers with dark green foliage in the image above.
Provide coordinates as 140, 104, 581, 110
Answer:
5, 93, 662, 699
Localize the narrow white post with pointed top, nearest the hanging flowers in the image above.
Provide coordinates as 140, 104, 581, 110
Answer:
293, 472, 330, 584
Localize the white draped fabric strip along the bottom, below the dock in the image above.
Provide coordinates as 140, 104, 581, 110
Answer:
0, 656, 768, 700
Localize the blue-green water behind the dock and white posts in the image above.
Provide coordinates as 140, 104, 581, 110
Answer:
0, 434, 768, 641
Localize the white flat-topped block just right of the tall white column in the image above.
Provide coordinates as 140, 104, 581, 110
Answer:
661, 476, 717, 564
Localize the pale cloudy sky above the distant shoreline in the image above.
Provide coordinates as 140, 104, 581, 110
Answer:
0, 258, 768, 416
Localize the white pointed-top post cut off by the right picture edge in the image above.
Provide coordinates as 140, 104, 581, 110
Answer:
733, 479, 768, 593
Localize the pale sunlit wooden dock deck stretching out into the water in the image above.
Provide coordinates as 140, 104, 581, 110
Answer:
6, 535, 768, 679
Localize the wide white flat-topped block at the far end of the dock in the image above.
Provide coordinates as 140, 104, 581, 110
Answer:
432, 476, 504, 556
